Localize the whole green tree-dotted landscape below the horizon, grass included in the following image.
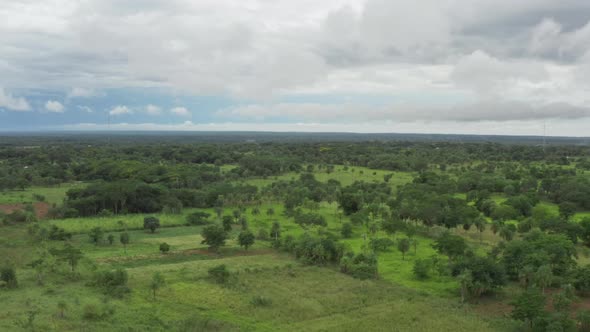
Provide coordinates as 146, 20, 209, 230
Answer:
0, 134, 590, 331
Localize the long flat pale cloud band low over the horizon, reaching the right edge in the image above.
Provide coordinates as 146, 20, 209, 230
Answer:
218, 100, 590, 123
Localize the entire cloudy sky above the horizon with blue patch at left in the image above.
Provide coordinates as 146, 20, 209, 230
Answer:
0, 0, 590, 136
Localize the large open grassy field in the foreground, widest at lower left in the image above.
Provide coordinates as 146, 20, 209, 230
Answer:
0, 220, 511, 331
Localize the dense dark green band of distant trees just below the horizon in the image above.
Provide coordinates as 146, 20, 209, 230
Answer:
0, 139, 590, 190
